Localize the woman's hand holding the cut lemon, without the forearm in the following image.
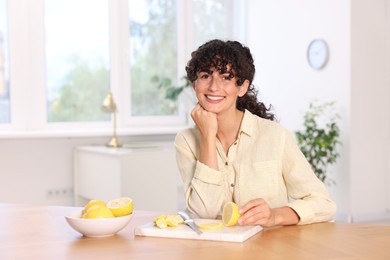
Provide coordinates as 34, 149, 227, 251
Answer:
238, 198, 275, 227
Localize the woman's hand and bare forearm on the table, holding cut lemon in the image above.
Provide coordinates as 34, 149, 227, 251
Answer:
238, 198, 299, 227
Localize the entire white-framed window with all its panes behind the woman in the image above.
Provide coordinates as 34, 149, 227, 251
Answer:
0, 0, 244, 136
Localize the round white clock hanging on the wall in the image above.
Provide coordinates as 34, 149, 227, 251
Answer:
307, 39, 329, 70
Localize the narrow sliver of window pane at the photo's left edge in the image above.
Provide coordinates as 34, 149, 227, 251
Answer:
0, 0, 10, 124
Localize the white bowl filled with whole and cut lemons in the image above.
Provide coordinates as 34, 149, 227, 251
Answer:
65, 197, 133, 237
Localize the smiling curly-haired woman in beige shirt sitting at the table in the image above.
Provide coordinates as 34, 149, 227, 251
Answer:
175, 40, 336, 227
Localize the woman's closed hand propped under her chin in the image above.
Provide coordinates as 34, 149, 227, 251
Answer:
191, 103, 218, 138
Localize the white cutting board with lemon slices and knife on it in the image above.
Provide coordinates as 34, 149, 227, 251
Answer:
134, 219, 263, 242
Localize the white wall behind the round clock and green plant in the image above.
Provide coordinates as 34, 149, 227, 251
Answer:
247, 0, 390, 221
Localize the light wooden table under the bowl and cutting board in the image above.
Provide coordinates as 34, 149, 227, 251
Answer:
0, 204, 390, 260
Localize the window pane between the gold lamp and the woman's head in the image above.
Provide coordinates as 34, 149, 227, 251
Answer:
129, 0, 177, 116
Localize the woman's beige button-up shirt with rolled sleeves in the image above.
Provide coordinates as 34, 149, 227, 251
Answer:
175, 108, 336, 225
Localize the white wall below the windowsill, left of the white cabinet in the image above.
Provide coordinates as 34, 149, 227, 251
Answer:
0, 135, 173, 205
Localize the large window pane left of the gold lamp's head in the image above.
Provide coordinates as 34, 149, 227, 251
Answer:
44, 0, 110, 122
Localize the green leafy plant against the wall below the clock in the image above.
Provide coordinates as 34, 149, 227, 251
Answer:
295, 101, 341, 184
